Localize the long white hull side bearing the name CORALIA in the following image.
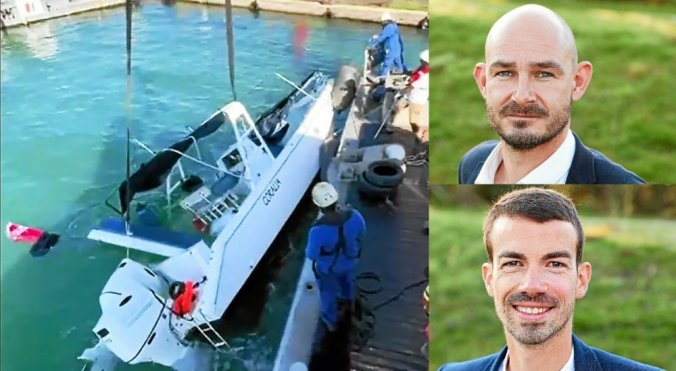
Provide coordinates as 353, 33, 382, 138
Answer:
198, 81, 334, 321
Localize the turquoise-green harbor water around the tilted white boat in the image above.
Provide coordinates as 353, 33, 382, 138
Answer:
0, 3, 428, 371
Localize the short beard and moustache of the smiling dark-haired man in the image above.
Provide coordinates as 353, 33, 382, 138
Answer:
496, 293, 575, 345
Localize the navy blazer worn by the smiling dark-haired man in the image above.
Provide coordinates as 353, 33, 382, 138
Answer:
439, 335, 660, 371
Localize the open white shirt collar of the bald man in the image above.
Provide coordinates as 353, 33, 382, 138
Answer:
474, 130, 575, 184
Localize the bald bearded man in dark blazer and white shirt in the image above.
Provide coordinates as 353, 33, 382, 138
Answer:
458, 5, 645, 184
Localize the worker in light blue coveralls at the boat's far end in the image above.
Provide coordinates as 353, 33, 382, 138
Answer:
368, 12, 406, 77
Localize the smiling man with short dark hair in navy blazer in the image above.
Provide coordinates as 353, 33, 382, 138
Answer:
439, 188, 657, 371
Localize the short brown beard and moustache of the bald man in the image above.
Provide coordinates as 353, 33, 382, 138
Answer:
486, 99, 573, 151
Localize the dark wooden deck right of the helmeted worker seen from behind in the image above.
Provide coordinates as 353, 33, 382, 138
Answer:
348, 125, 429, 370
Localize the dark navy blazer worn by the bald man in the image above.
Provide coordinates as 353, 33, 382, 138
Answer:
458, 133, 645, 184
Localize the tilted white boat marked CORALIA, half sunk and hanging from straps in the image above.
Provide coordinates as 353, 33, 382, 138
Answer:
80, 72, 334, 370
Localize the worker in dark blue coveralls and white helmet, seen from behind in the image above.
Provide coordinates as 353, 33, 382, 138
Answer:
305, 182, 366, 332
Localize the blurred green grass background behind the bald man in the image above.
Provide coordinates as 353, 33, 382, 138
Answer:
430, 0, 676, 184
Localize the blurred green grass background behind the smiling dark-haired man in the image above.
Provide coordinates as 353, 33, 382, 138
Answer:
430, 206, 676, 370
